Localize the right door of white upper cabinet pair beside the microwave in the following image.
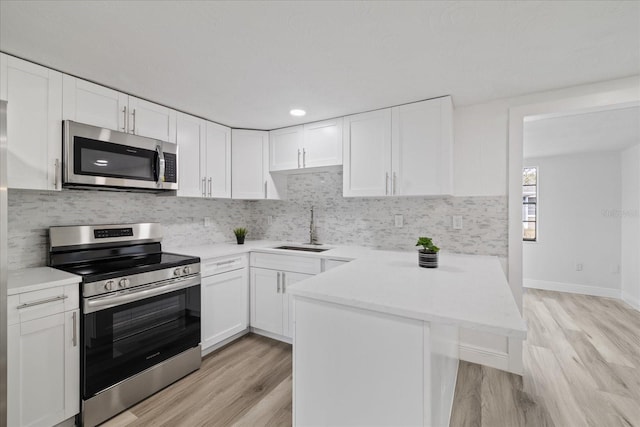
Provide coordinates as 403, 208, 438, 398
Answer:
201, 122, 231, 199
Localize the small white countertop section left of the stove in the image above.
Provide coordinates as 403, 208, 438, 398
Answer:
7, 267, 82, 295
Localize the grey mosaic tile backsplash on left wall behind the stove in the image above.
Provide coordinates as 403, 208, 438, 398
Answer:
8, 189, 250, 269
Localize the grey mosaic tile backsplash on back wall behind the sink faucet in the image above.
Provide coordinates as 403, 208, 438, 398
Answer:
250, 172, 508, 257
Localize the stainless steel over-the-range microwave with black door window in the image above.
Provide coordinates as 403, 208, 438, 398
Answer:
62, 120, 178, 191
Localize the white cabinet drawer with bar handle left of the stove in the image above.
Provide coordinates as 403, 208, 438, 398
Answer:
7, 284, 78, 325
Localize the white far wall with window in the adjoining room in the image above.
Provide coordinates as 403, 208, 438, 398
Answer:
523, 151, 622, 297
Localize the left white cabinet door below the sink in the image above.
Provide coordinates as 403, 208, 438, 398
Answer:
251, 268, 284, 335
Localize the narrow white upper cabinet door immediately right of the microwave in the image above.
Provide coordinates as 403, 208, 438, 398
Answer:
176, 113, 206, 201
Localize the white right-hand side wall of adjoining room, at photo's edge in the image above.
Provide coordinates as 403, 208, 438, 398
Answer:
620, 144, 640, 310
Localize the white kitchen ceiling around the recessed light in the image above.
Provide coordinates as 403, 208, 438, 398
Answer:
0, 0, 640, 129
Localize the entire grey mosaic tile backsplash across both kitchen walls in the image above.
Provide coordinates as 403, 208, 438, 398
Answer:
8, 171, 508, 269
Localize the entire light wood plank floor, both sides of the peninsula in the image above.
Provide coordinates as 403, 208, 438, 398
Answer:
104, 290, 640, 427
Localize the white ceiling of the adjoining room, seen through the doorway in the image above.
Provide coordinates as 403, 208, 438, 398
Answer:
523, 106, 640, 159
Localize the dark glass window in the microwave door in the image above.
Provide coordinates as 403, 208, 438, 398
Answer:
74, 137, 156, 181
